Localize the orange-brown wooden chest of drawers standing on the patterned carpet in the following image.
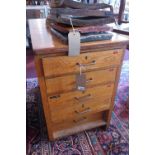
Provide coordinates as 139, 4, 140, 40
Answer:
29, 19, 128, 140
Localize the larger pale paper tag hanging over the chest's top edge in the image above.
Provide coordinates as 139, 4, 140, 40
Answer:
68, 32, 80, 56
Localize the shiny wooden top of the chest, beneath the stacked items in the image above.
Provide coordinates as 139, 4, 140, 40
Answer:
29, 19, 128, 55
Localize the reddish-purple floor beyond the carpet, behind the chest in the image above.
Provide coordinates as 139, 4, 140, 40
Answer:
26, 49, 129, 78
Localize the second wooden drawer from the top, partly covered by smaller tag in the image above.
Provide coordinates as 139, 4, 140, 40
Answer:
45, 68, 117, 94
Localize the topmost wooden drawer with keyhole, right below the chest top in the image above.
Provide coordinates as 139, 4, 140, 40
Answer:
42, 49, 123, 77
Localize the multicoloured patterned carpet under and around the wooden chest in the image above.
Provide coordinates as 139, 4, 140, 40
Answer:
26, 61, 129, 155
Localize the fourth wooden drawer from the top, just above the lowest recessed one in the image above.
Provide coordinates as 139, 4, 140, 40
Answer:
51, 96, 111, 123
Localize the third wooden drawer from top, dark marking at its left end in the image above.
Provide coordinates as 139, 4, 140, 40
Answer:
48, 84, 114, 111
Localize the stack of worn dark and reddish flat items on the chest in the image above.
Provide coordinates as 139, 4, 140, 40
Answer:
46, 0, 115, 43
